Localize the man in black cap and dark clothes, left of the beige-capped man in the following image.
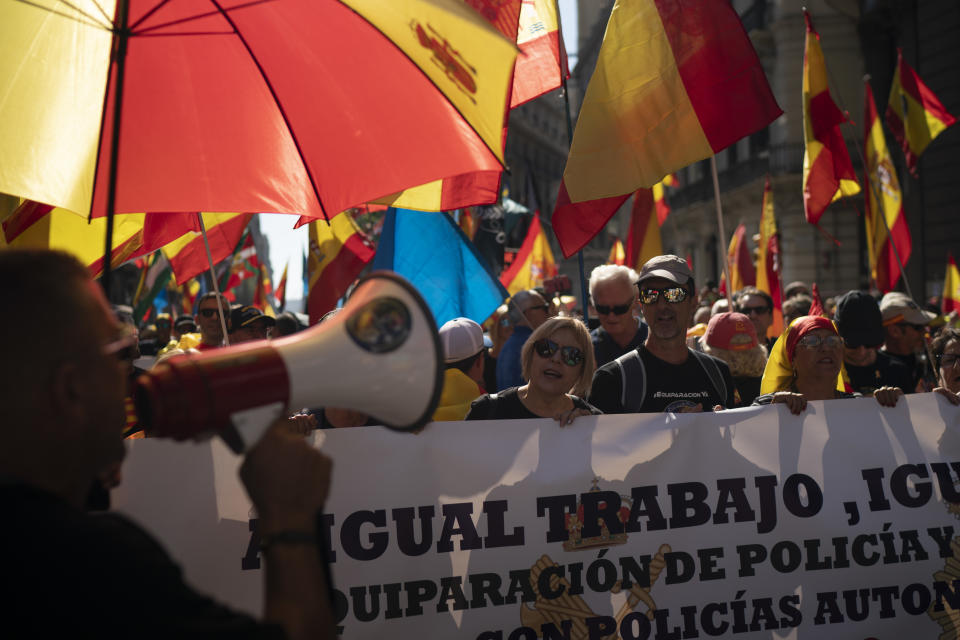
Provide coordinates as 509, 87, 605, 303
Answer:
834, 291, 915, 395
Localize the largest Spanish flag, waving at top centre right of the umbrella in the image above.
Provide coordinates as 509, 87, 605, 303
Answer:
552, 0, 782, 257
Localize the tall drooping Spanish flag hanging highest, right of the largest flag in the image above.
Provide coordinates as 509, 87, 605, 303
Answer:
803, 11, 860, 225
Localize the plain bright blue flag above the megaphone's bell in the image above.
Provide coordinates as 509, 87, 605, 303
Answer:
373, 208, 510, 327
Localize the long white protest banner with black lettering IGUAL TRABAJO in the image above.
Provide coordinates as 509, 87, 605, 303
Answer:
113, 394, 960, 640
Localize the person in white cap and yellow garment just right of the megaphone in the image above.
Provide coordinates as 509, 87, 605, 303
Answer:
433, 318, 484, 422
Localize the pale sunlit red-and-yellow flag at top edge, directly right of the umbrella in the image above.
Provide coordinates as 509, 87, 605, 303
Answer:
510, 0, 570, 109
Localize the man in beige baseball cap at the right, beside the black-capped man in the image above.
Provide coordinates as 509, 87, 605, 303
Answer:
880, 291, 937, 393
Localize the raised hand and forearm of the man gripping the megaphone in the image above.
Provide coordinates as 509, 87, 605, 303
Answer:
240, 418, 336, 638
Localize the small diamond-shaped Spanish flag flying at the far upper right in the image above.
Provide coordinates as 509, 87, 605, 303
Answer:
886, 48, 957, 176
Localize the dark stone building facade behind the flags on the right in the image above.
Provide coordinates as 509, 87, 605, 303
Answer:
571, 0, 960, 297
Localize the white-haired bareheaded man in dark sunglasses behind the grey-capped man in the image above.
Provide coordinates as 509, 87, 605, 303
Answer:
590, 264, 647, 367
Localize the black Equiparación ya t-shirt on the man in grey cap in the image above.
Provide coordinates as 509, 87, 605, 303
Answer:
588, 346, 736, 413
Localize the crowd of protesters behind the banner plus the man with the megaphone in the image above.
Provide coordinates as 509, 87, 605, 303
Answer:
0, 250, 960, 638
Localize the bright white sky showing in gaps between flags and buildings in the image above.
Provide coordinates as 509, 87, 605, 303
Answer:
259, 0, 577, 311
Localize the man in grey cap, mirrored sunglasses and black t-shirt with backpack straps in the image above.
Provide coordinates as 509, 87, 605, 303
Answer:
589, 255, 735, 413
